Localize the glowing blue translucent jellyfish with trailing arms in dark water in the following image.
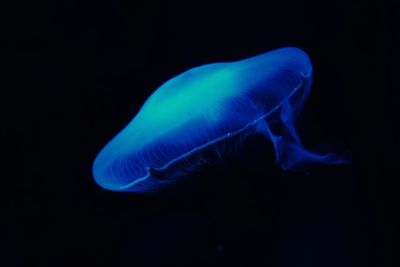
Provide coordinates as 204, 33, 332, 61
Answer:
93, 48, 343, 192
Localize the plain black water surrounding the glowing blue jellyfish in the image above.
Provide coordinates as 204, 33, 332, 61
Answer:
0, 0, 400, 267
